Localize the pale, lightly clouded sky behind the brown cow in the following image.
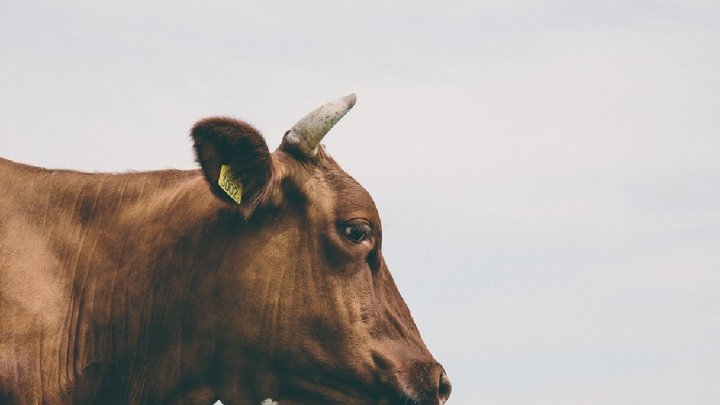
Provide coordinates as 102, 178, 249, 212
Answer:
0, 0, 720, 405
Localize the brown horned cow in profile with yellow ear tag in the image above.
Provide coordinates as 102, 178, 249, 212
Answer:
0, 94, 451, 405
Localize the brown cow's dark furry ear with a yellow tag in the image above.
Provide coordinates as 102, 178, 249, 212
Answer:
192, 117, 272, 216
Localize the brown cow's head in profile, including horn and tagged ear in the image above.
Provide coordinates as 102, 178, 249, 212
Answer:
192, 95, 450, 405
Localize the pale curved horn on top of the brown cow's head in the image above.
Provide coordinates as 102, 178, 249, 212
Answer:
283, 93, 357, 157
